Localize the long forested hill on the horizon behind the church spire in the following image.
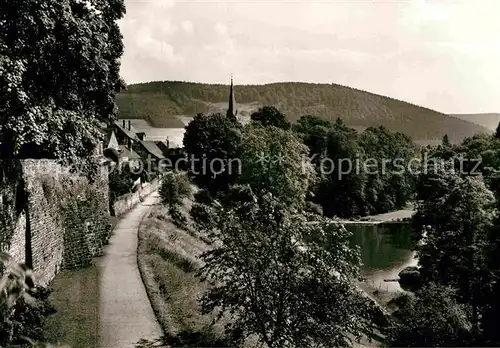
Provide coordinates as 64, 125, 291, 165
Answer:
117, 81, 489, 141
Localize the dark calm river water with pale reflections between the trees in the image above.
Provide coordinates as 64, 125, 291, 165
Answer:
345, 223, 417, 292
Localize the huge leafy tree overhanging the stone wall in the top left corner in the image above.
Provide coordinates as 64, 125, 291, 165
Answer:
0, 0, 125, 158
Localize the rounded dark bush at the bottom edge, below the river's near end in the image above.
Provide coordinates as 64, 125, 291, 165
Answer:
387, 283, 471, 347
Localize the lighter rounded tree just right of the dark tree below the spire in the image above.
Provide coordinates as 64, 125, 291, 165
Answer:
238, 124, 315, 205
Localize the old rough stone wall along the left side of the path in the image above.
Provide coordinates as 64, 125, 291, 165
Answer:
0, 160, 110, 284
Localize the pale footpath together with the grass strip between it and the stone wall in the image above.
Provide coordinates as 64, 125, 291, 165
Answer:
44, 193, 163, 348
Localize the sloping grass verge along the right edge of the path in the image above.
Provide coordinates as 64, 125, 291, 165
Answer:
138, 205, 228, 347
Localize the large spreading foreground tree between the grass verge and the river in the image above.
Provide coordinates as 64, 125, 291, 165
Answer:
197, 186, 376, 348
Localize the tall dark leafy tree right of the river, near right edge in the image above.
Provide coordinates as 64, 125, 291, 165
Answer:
413, 168, 494, 336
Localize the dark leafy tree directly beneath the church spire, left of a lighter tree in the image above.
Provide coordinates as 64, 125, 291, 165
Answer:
183, 114, 241, 193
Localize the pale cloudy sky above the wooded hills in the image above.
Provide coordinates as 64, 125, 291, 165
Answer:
120, 0, 500, 113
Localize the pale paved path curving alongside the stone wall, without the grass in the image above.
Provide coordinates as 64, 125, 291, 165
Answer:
97, 193, 163, 348
